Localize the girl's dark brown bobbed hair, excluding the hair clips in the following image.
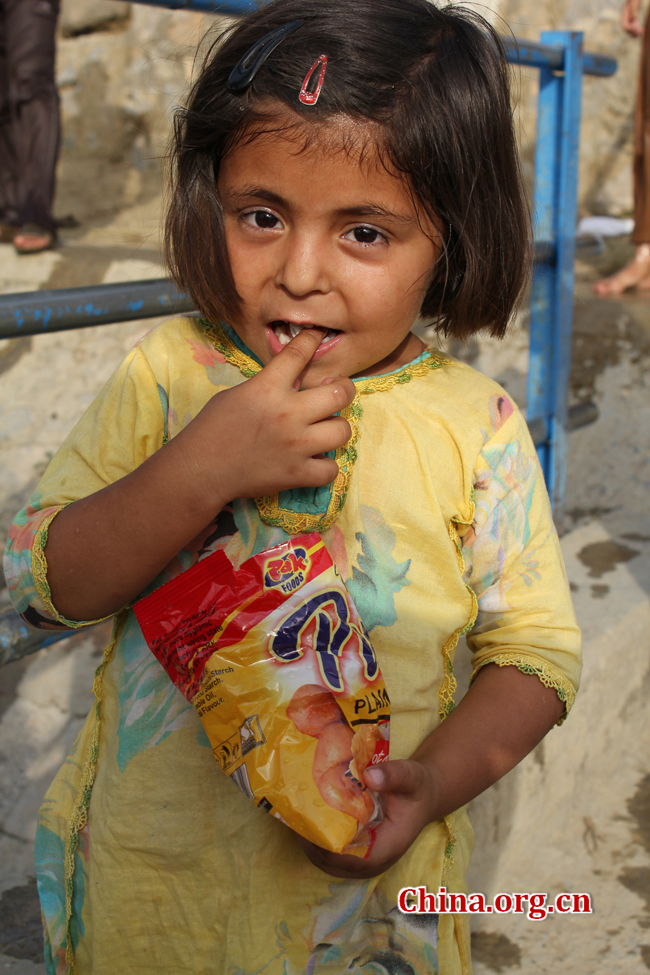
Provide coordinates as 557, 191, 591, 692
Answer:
165, 0, 529, 338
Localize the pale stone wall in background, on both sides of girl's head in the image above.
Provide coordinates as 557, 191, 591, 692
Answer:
50, 0, 641, 219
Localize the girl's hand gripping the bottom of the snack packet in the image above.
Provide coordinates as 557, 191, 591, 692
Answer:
299, 759, 440, 880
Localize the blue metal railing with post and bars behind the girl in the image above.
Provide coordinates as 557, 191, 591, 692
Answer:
0, 13, 616, 666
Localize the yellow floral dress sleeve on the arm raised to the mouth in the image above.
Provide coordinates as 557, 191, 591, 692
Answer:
3, 348, 167, 629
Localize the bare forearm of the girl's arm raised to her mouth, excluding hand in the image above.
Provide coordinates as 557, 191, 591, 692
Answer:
45, 440, 231, 620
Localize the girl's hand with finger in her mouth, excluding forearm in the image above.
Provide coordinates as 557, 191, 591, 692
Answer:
175, 328, 355, 510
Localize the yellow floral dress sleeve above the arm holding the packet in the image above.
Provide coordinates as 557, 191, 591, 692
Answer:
461, 401, 581, 723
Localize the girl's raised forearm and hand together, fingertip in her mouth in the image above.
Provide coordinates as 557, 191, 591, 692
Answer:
47, 328, 355, 620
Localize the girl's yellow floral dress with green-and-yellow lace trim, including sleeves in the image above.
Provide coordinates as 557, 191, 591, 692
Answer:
0, 318, 580, 975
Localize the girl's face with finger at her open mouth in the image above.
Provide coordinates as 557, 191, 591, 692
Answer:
218, 117, 439, 387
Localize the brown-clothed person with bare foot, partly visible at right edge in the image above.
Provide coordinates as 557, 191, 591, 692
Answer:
594, 0, 650, 297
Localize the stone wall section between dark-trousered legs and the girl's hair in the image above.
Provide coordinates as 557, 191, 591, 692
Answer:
56, 0, 230, 222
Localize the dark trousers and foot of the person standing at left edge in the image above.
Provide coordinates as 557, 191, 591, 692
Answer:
0, 0, 59, 253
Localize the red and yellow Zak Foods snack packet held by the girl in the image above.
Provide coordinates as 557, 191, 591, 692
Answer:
134, 532, 390, 856
